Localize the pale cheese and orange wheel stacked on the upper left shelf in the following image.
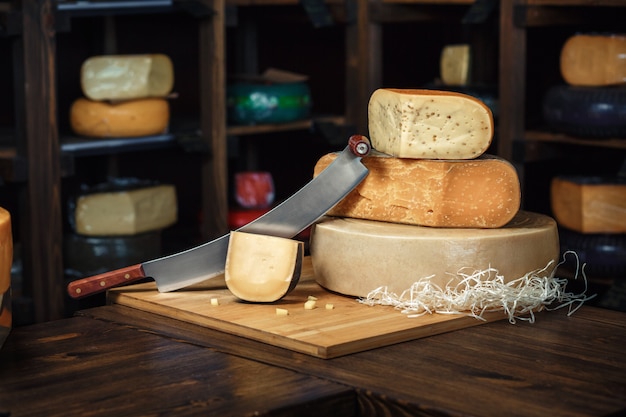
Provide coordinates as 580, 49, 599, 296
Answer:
70, 54, 174, 138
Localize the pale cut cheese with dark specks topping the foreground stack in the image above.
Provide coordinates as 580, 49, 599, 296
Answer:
368, 89, 494, 159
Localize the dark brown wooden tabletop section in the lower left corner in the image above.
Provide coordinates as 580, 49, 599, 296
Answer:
0, 317, 355, 417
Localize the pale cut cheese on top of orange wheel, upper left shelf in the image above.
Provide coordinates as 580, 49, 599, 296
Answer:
80, 54, 174, 100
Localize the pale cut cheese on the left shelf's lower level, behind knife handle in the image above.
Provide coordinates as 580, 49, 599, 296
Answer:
74, 185, 178, 236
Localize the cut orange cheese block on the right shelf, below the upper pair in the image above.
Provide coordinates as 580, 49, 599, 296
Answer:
550, 177, 626, 233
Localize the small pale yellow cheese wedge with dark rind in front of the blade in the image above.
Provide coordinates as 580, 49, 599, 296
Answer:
224, 231, 304, 303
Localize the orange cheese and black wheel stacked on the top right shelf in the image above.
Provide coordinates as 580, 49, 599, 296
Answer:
543, 33, 626, 139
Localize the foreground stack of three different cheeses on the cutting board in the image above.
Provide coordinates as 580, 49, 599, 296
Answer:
310, 89, 559, 297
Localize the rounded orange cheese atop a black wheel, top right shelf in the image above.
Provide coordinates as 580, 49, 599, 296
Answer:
561, 34, 626, 87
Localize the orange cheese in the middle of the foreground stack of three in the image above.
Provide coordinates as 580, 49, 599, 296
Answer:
314, 154, 521, 228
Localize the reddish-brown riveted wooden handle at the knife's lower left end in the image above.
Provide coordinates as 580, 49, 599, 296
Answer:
67, 264, 146, 298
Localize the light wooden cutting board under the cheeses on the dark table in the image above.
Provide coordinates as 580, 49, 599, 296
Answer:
107, 257, 506, 359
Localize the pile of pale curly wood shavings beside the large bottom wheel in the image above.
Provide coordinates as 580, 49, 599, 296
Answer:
358, 251, 595, 324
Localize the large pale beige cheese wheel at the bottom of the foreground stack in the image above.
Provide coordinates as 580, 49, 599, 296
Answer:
310, 211, 559, 297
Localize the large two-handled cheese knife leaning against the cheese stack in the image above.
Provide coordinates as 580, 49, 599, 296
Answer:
67, 135, 371, 298
